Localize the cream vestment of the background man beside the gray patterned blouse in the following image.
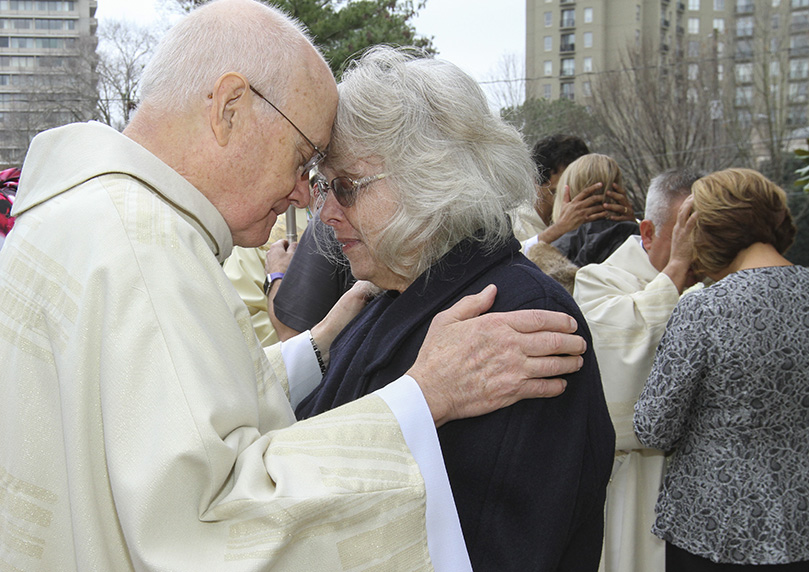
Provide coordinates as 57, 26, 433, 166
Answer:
573, 236, 680, 572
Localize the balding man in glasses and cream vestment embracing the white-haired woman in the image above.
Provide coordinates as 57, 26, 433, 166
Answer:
0, 0, 584, 572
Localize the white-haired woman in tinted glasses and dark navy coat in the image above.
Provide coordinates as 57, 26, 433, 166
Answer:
298, 48, 614, 572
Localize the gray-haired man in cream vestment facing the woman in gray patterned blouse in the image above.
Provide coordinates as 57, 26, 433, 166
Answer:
573, 169, 700, 572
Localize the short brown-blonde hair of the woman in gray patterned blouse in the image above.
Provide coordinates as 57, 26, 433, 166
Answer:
692, 169, 796, 273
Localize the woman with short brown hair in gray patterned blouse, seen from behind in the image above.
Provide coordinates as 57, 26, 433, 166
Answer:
634, 169, 809, 572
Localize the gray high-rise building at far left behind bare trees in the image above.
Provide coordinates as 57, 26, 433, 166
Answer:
0, 0, 98, 167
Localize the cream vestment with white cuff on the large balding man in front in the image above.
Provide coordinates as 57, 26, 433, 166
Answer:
0, 123, 470, 572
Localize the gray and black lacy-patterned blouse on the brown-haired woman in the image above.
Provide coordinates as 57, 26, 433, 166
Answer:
634, 266, 809, 564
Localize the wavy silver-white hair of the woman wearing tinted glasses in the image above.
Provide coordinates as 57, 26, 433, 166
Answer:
327, 46, 536, 280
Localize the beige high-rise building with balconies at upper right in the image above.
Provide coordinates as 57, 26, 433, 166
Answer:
526, 0, 809, 129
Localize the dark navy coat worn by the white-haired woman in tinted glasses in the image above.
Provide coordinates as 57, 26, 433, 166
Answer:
297, 235, 615, 572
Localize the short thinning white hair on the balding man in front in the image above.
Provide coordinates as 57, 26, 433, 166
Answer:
141, 0, 311, 112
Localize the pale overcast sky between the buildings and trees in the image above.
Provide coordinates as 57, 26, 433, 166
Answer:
96, 0, 525, 101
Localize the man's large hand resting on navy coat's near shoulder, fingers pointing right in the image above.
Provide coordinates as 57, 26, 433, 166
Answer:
407, 285, 587, 426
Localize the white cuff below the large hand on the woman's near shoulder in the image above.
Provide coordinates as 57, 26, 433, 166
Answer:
374, 375, 472, 572
